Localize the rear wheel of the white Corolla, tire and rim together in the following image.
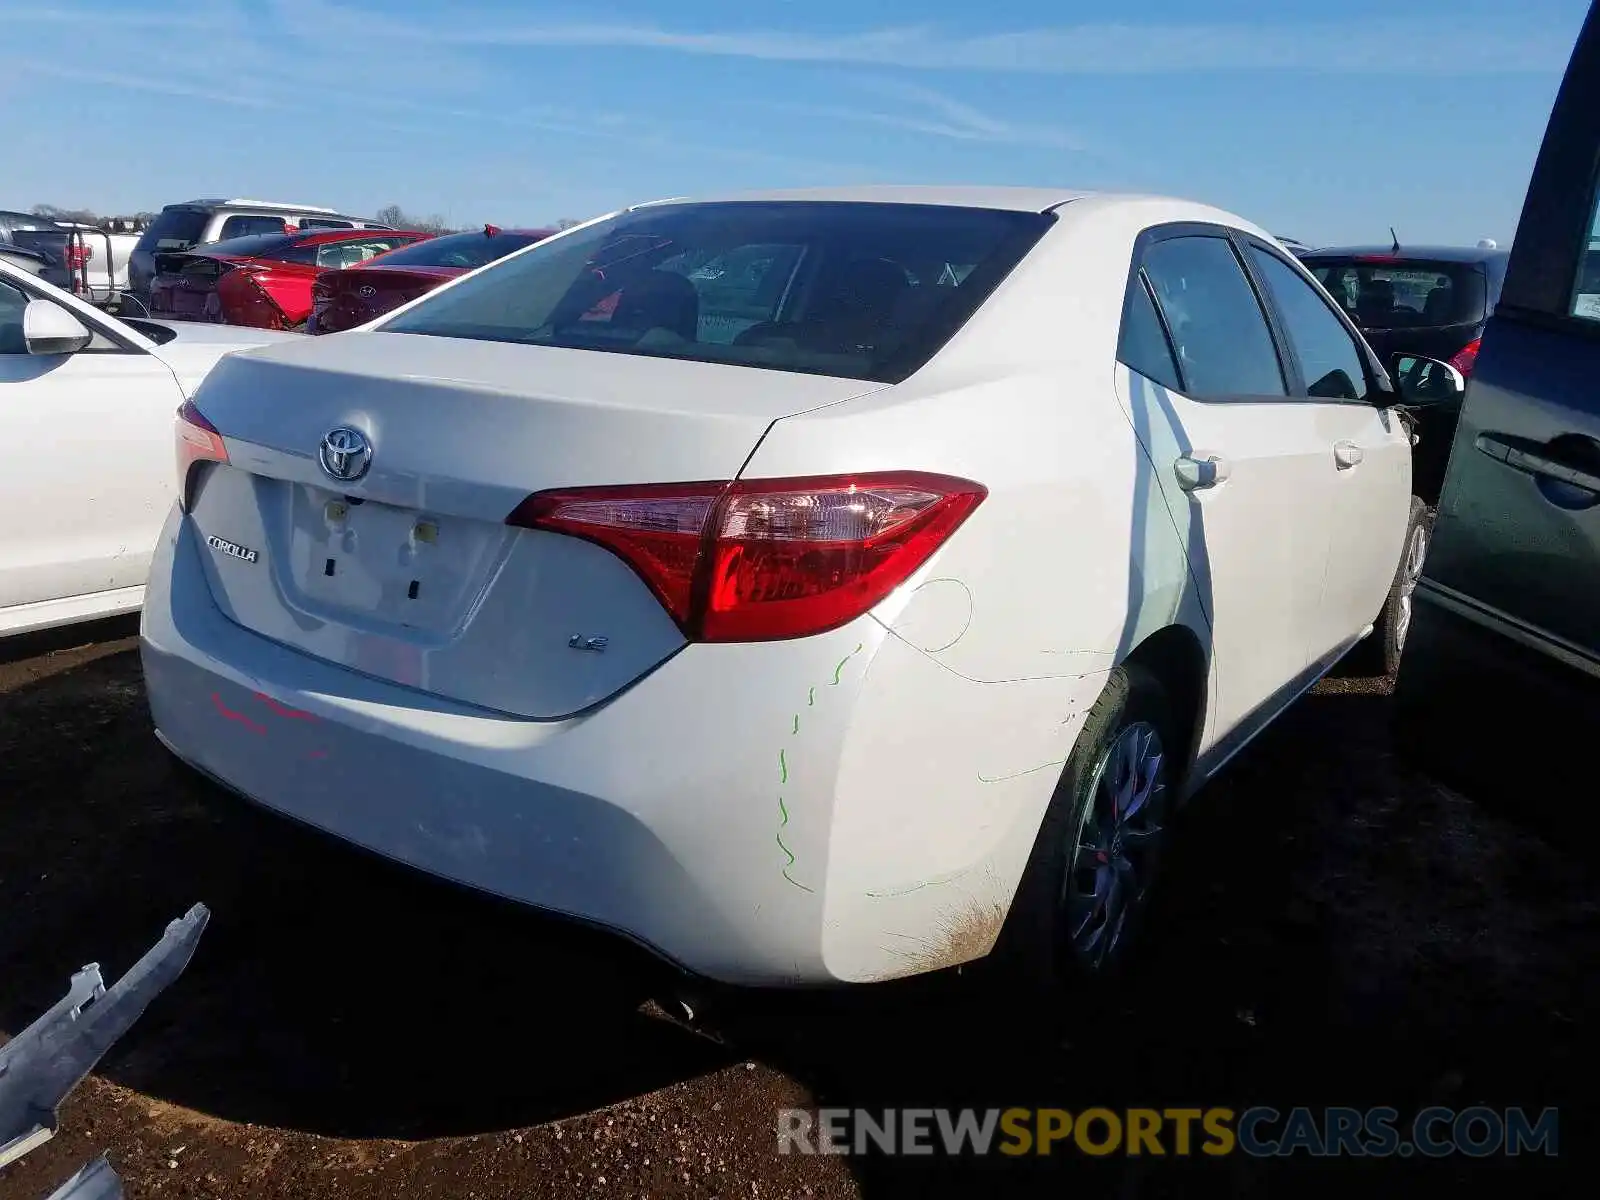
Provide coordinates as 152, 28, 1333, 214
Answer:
1003, 664, 1179, 995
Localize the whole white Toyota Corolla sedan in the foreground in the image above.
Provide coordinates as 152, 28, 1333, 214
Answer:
142, 187, 1427, 984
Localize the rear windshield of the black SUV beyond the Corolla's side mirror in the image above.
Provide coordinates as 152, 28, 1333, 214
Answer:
1304, 254, 1488, 330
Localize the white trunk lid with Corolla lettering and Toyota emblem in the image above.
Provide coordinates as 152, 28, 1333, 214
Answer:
190, 333, 880, 718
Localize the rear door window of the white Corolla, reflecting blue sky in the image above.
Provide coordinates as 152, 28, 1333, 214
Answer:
1144, 235, 1290, 400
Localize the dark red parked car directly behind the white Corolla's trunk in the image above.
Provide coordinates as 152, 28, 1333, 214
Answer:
306, 226, 555, 333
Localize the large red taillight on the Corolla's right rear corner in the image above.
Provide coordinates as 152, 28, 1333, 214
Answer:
506, 470, 989, 642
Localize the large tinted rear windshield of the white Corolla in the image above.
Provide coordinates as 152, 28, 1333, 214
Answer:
379, 202, 1054, 382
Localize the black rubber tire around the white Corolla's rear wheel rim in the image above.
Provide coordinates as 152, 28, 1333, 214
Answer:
1000, 664, 1187, 1003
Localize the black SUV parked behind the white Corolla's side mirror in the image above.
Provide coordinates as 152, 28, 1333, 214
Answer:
1299, 246, 1509, 506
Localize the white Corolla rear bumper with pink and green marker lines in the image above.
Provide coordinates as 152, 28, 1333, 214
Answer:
141, 512, 1098, 986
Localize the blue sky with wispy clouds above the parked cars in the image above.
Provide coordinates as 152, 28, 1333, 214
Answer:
0, 0, 1587, 243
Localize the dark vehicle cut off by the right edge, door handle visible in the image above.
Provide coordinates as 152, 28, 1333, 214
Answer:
1395, 5, 1600, 819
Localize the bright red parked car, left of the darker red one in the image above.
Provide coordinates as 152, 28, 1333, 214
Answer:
149, 229, 430, 330
